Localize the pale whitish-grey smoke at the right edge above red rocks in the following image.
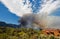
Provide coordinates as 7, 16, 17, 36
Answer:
47, 16, 60, 29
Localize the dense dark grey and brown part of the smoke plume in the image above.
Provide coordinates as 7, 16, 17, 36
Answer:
20, 14, 47, 29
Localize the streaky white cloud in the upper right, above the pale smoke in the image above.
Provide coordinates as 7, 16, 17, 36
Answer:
39, 0, 60, 15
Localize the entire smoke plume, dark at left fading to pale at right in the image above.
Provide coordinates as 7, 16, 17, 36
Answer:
20, 14, 60, 29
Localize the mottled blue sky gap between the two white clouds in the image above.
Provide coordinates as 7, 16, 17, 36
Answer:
30, 0, 41, 13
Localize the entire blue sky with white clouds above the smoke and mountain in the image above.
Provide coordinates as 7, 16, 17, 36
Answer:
0, 0, 60, 26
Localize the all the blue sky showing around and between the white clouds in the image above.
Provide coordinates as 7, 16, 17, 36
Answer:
0, 0, 60, 24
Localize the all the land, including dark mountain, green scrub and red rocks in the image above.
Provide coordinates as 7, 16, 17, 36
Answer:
0, 22, 60, 39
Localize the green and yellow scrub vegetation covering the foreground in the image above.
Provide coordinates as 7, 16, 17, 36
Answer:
0, 27, 60, 39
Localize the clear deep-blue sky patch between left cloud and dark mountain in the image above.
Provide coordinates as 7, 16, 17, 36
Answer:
0, 2, 19, 24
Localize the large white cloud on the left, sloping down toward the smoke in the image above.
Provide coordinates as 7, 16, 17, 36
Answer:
1, 0, 32, 16
